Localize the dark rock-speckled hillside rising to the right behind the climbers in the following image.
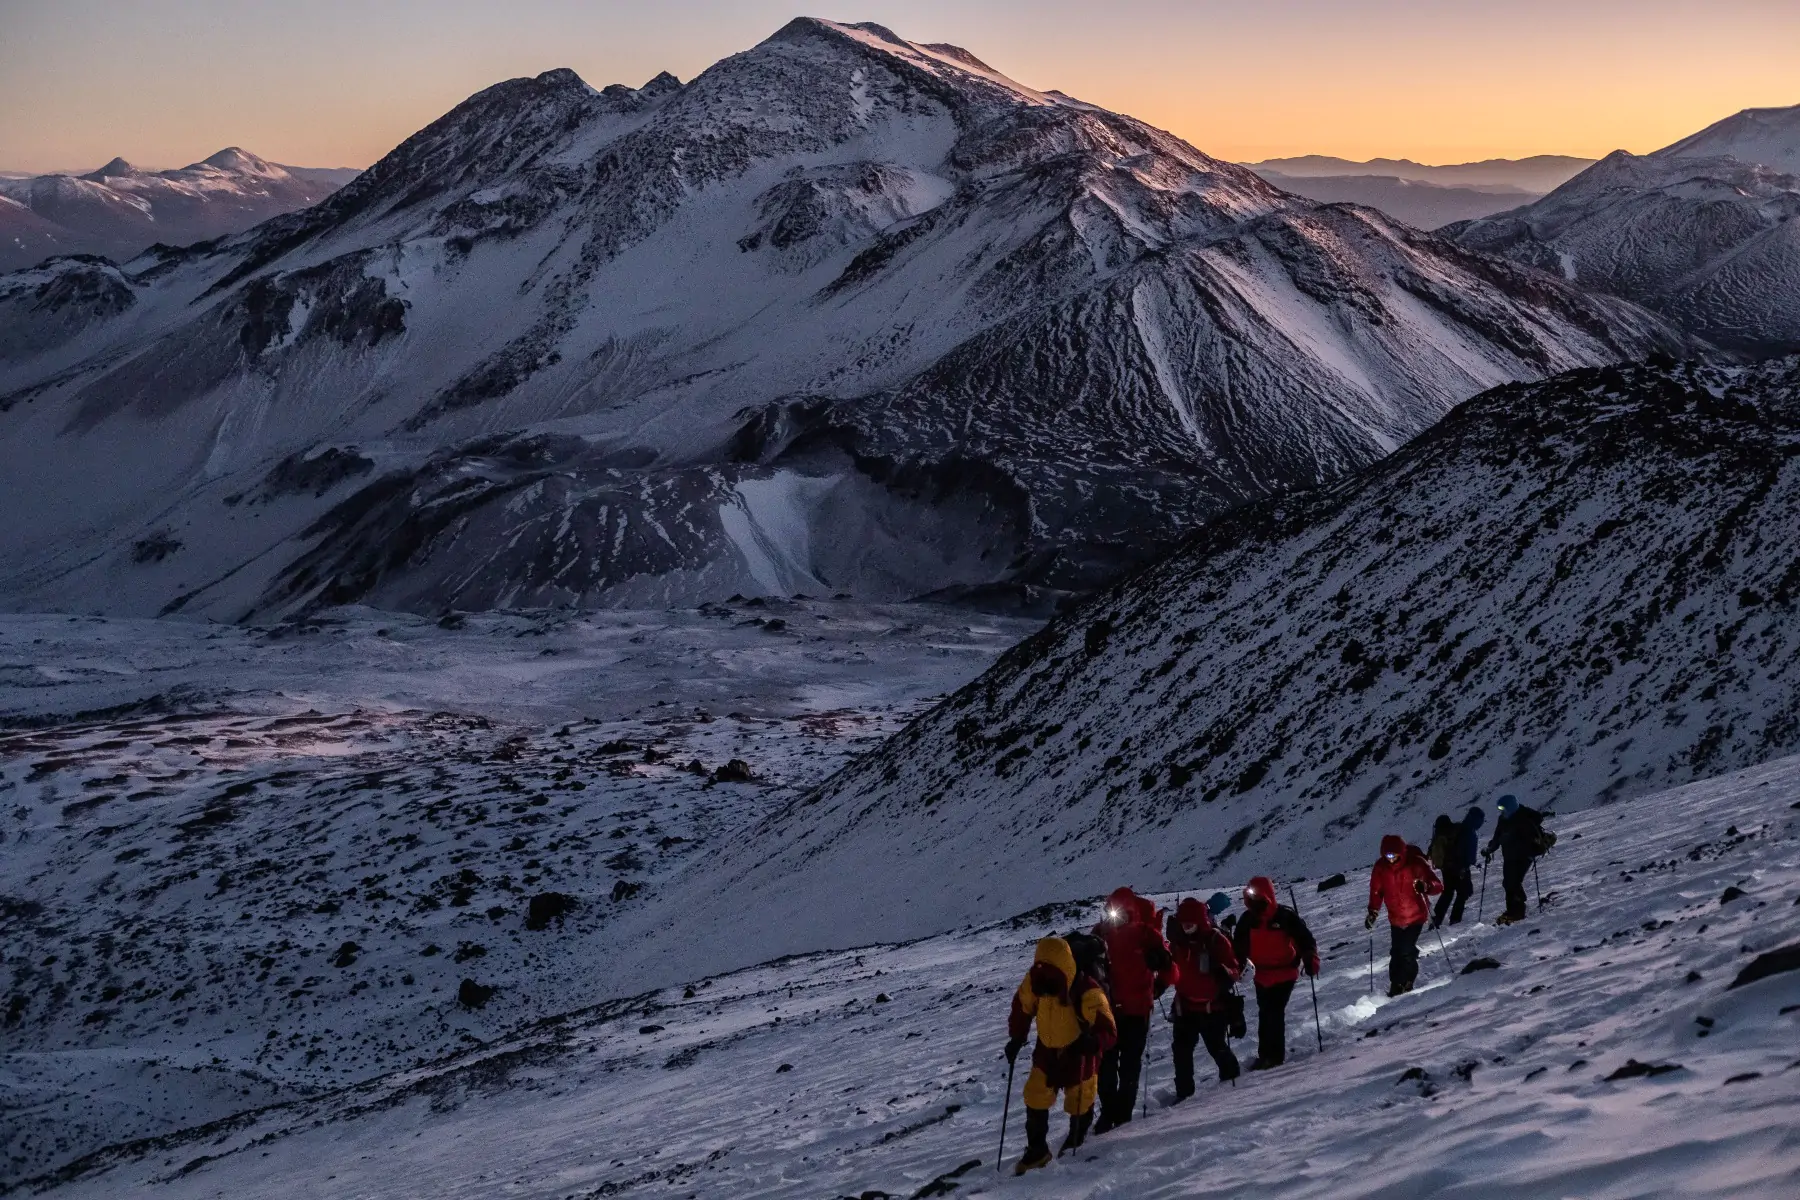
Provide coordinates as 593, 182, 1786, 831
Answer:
666, 360, 1800, 945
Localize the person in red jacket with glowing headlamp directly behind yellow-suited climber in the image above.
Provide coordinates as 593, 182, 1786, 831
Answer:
1094, 887, 1174, 1133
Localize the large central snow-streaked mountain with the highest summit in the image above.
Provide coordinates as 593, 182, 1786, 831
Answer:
0, 20, 1679, 619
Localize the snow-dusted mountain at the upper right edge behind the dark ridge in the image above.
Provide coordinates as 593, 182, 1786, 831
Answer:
1442, 106, 1800, 356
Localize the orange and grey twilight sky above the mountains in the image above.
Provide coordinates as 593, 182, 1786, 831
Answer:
0, 0, 1800, 171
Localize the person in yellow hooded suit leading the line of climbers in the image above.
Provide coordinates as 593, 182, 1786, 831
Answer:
1006, 937, 1118, 1175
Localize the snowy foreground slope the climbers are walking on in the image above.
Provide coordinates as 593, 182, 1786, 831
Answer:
31, 757, 1800, 1200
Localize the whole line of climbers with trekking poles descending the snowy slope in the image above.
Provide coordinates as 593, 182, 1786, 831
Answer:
1006, 795, 1555, 1175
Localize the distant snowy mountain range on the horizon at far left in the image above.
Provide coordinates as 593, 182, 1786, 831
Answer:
0, 146, 358, 272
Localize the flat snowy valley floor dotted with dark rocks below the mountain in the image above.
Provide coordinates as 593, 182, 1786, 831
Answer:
0, 599, 1035, 1184
